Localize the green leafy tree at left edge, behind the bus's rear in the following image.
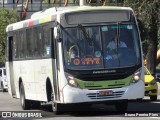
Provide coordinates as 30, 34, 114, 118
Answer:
0, 9, 18, 66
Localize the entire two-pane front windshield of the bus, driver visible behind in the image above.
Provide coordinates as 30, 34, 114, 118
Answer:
63, 23, 141, 70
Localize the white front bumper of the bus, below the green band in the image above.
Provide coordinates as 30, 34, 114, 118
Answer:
61, 80, 144, 104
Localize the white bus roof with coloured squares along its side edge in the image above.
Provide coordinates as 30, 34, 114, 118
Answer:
6, 6, 132, 32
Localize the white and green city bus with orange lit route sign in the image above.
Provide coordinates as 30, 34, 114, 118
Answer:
6, 6, 144, 114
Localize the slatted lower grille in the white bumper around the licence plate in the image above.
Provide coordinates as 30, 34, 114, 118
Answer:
87, 91, 124, 99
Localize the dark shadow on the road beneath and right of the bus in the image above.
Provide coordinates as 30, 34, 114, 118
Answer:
37, 100, 160, 117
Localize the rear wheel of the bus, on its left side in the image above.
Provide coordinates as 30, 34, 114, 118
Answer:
20, 83, 31, 110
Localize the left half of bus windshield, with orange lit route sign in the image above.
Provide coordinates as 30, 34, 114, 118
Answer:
63, 26, 103, 68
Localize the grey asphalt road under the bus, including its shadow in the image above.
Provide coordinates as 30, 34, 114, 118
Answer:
0, 88, 160, 120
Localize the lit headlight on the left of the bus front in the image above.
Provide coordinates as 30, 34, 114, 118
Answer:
65, 73, 78, 88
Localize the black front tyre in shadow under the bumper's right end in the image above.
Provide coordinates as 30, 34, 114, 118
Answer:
115, 101, 128, 112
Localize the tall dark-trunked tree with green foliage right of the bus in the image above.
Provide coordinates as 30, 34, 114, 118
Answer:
124, 0, 160, 74
